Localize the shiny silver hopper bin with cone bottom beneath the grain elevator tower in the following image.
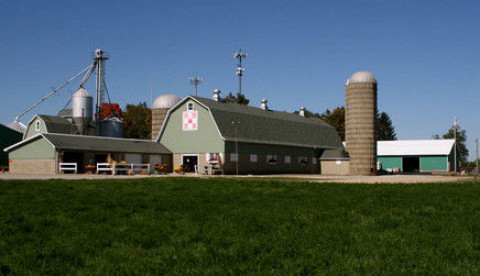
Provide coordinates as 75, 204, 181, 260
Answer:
72, 87, 93, 134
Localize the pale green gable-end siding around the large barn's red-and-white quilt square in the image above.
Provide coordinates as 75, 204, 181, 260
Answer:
160, 101, 225, 153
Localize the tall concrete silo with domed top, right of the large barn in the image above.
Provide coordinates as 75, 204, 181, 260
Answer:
345, 71, 377, 175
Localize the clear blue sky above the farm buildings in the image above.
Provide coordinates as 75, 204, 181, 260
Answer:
0, 0, 480, 157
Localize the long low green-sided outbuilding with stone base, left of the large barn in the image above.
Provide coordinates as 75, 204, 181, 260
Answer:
5, 133, 171, 174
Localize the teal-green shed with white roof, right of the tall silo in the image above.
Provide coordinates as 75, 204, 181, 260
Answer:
377, 139, 459, 173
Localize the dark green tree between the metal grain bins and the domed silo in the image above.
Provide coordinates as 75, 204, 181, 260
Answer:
123, 102, 152, 139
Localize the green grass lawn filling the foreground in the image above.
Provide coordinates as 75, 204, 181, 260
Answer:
0, 178, 480, 274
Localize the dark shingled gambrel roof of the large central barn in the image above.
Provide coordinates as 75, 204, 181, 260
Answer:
186, 96, 341, 149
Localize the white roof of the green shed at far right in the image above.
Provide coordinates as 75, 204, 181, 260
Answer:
377, 139, 455, 156
